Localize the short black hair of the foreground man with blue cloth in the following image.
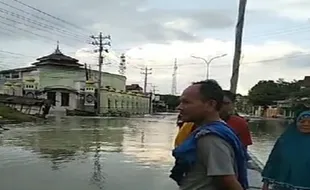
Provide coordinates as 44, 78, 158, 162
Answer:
193, 79, 224, 110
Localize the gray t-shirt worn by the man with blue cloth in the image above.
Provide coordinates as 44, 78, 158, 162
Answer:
180, 135, 237, 190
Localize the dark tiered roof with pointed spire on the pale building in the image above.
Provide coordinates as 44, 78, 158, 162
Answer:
32, 42, 82, 67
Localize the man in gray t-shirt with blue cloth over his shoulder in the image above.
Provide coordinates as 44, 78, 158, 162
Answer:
170, 80, 248, 190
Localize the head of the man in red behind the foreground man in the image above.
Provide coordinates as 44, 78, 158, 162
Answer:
221, 90, 236, 119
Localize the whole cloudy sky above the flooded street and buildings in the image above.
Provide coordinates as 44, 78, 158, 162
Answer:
0, 0, 310, 95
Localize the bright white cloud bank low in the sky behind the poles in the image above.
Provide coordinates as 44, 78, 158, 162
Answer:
97, 39, 310, 94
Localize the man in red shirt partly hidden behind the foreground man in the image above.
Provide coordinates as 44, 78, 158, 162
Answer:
220, 90, 252, 149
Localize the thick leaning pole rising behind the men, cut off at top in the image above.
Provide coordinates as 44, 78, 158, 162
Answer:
230, 0, 247, 93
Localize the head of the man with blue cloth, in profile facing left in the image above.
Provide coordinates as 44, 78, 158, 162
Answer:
178, 80, 224, 122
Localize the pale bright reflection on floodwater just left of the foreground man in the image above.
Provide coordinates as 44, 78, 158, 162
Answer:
123, 119, 176, 164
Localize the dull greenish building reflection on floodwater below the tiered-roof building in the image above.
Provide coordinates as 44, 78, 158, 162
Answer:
4, 118, 127, 169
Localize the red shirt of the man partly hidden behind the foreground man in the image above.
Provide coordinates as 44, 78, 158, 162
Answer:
226, 115, 253, 147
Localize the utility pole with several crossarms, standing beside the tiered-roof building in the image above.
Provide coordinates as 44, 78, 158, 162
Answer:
91, 32, 111, 114
